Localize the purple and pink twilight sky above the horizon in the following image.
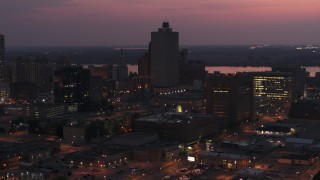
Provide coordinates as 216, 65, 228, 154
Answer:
0, 0, 320, 46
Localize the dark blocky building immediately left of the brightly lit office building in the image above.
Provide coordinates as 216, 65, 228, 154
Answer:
205, 74, 252, 125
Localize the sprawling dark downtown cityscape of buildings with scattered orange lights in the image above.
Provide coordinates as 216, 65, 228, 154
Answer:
0, 22, 320, 179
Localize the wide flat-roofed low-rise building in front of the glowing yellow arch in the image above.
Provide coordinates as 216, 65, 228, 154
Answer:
134, 112, 219, 143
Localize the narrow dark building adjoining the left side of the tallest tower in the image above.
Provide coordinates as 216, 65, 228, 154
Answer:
138, 43, 151, 76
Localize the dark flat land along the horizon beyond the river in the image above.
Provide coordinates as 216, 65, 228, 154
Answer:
6, 45, 320, 67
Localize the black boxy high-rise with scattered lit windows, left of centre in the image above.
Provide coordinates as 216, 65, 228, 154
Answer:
54, 67, 90, 110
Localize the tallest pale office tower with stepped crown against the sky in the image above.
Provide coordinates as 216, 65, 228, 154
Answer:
151, 22, 179, 88
